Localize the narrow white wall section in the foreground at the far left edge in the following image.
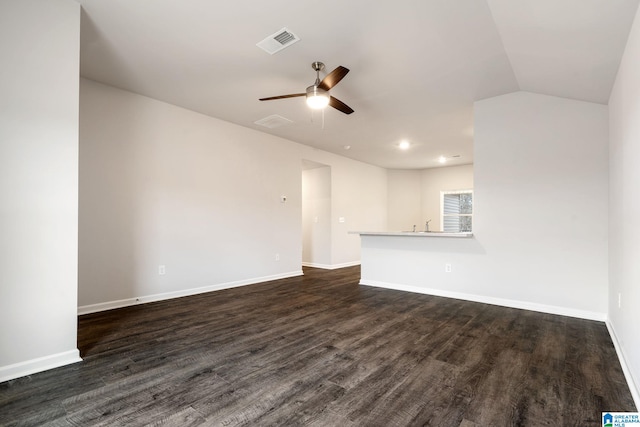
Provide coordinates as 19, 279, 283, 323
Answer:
0, 0, 80, 381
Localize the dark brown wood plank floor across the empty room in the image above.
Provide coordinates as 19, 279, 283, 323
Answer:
0, 267, 636, 427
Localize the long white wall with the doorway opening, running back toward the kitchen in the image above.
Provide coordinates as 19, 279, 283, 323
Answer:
79, 80, 386, 312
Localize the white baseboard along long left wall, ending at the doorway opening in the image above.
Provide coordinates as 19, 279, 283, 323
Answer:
78, 270, 302, 315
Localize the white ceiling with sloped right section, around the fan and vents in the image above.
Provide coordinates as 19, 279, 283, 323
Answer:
79, 0, 640, 168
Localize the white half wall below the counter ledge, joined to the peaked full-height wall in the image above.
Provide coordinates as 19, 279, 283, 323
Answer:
362, 92, 608, 320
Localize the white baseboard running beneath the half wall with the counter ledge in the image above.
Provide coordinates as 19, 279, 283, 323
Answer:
360, 279, 607, 322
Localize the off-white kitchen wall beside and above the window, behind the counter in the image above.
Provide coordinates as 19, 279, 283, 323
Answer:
387, 165, 473, 231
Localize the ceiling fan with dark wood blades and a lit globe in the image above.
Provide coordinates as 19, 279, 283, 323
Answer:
260, 61, 353, 114
